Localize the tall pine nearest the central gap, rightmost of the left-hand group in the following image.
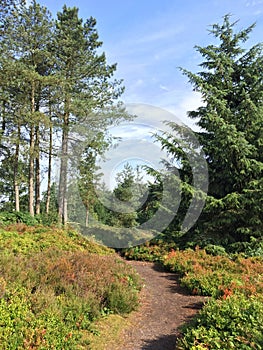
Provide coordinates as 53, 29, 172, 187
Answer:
54, 6, 123, 226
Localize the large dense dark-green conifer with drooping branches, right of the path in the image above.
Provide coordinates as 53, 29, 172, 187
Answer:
146, 15, 263, 251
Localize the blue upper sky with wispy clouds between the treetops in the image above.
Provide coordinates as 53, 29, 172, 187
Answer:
39, 0, 263, 126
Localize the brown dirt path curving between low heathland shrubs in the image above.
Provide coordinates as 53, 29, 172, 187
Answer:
116, 261, 204, 350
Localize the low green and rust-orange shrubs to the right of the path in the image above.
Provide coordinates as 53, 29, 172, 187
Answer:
163, 247, 263, 350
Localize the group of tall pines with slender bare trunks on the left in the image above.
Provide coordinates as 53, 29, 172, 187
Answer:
0, 0, 127, 222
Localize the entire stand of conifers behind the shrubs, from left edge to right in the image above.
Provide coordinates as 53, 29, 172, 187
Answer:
0, 1, 263, 250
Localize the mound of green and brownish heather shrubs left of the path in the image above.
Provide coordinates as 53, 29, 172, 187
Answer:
0, 224, 141, 350
